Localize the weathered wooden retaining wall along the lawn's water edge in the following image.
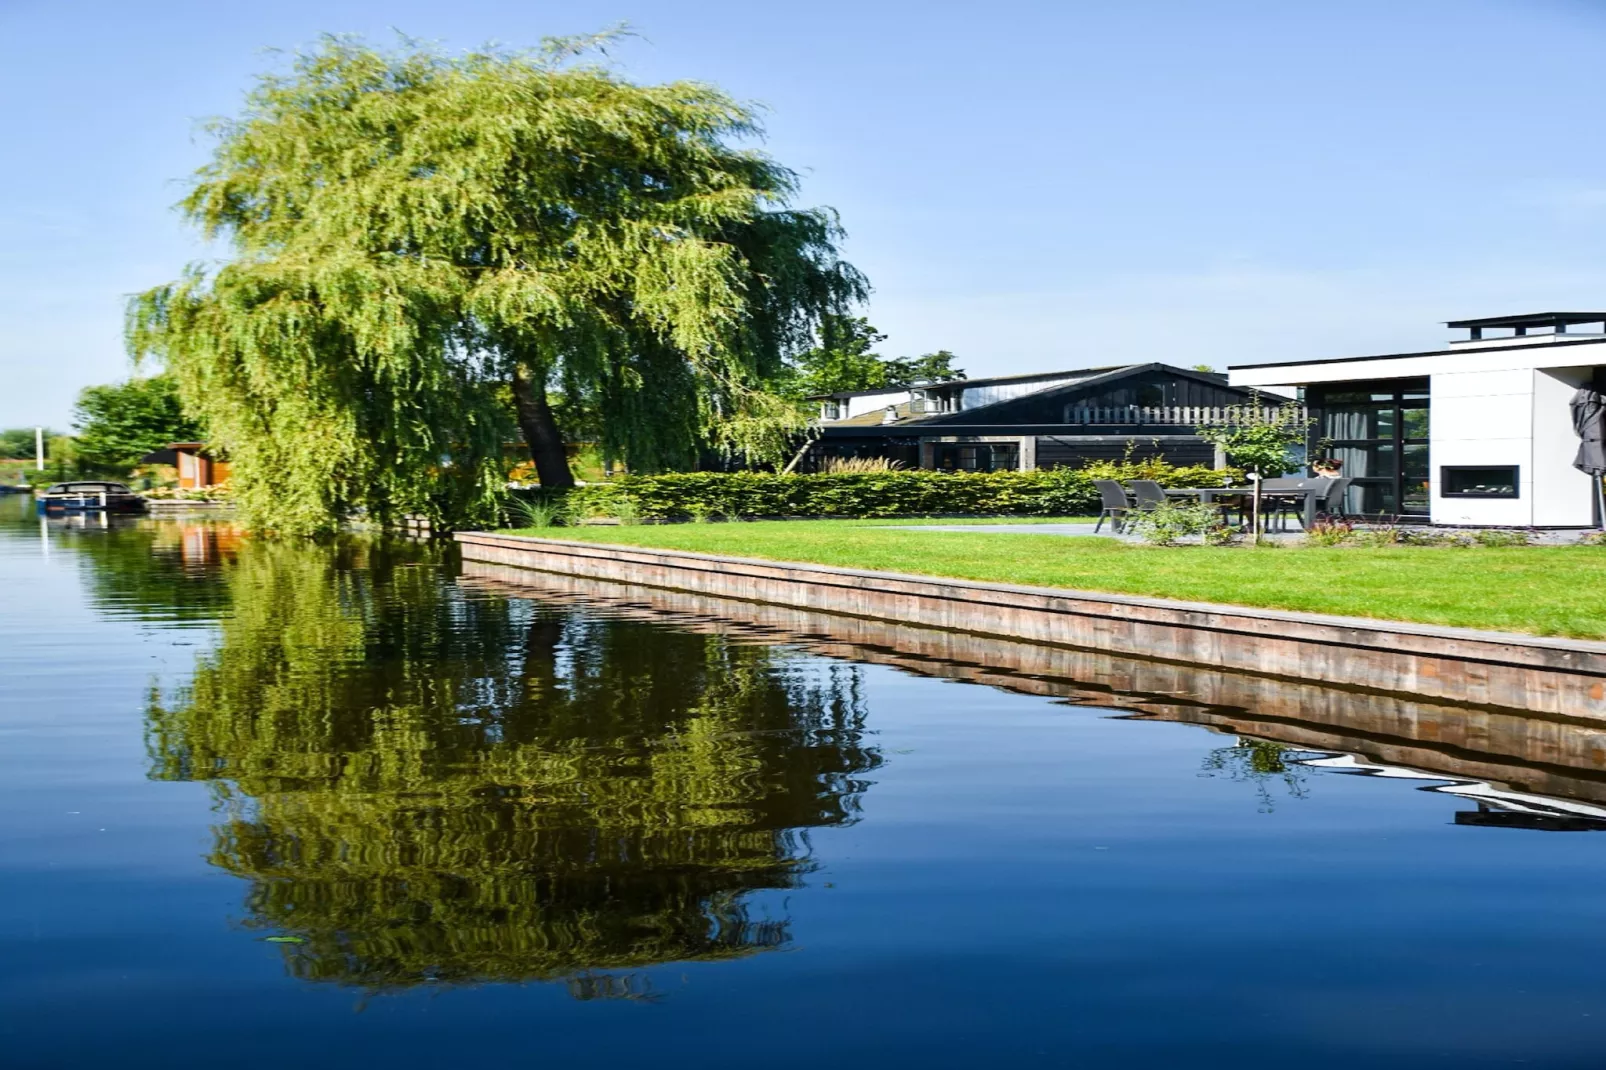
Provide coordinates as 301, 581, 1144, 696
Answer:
456, 532, 1606, 721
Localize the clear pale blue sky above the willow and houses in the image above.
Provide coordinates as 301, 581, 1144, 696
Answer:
0, 0, 1606, 426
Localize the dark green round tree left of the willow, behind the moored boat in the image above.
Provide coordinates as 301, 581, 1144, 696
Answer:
74, 374, 202, 472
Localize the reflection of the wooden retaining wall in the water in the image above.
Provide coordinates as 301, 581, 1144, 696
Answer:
464, 561, 1606, 802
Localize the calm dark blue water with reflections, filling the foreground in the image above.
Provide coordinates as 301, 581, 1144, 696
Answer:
9, 503, 1606, 1070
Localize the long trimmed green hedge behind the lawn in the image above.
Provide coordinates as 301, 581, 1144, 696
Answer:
512, 461, 1240, 524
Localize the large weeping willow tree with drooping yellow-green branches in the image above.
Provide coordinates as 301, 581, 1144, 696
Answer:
128, 37, 866, 532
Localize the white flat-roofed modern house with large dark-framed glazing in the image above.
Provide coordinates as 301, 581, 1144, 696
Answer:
1229, 312, 1606, 527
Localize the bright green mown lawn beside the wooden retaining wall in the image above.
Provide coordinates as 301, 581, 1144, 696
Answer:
504, 521, 1606, 638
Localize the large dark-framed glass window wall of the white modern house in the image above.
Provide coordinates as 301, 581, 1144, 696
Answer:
1306, 379, 1428, 516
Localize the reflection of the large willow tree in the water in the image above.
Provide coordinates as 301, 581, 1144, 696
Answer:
149, 543, 878, 996
